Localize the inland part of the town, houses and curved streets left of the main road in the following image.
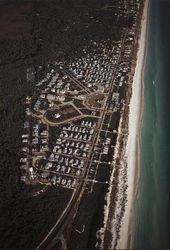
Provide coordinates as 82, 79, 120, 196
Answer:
21, 38, 125, 188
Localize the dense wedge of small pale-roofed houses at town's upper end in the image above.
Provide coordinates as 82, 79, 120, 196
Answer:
68, 40, 120, 92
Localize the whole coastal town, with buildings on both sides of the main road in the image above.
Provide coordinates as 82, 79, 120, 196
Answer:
20, 2, 141, 191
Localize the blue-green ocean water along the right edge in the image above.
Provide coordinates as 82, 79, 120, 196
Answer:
133, 0, 169, 250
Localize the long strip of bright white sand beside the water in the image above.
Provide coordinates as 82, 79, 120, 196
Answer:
116, 0, 149, 249
